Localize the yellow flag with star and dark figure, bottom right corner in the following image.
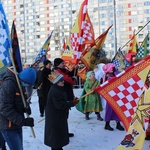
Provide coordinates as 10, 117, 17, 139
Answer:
117, 89, 150, 150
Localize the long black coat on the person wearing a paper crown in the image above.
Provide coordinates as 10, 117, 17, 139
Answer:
44, 84, 74, 149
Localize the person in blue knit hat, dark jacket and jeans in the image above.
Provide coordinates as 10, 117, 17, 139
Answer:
0, 68, 36, 150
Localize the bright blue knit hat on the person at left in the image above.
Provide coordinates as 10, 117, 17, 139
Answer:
18, 68, 36, 84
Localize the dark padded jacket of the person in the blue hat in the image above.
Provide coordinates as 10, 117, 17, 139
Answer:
0, 70, 25, 130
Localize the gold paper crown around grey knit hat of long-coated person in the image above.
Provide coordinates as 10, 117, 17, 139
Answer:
48, 70, 64, 84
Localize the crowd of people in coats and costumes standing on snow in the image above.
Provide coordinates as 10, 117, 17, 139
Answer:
0, 58, 149, 150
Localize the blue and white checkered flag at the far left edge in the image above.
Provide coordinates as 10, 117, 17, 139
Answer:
0, 2, 11, 78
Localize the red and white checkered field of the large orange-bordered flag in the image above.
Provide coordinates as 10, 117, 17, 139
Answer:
108, 75, 144, 122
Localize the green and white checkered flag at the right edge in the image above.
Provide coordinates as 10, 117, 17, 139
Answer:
136, 33, 150, 60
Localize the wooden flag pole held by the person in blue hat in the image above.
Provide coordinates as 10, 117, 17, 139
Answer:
9, 50, 36, 138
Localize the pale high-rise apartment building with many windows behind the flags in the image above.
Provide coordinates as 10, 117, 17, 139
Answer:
2, 0, 150, 63
